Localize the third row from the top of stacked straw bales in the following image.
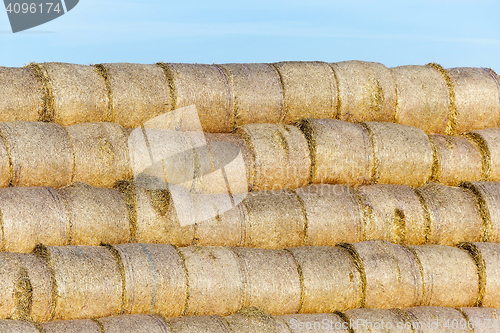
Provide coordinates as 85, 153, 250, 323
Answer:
0, 182, 500, 253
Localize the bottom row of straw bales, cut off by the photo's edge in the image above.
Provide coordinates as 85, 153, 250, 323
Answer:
0, 307, 500, 333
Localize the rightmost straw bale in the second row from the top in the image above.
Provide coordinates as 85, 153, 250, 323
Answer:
467, 128, 500, 181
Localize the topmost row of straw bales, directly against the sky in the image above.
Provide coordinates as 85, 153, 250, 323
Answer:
0, 61, 500, 135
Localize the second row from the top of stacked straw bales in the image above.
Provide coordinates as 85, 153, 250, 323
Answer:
0, 119, 500, 193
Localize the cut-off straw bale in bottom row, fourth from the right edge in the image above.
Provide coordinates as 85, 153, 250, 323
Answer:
282, 313, 351, 333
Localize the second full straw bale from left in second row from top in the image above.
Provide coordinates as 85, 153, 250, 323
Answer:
66, 123, 133, 187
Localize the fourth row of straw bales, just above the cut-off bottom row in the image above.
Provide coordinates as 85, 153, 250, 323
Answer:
0, 240, 500, 322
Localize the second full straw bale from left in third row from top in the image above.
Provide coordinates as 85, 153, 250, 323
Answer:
57, 183, 130, 246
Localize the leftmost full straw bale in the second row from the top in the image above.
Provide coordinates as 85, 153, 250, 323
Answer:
0, 121, 73, 187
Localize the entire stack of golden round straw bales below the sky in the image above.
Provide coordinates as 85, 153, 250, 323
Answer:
0, 61, 500, 333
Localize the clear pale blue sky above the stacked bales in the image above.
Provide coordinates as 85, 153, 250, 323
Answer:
0, 0, 500, 73
